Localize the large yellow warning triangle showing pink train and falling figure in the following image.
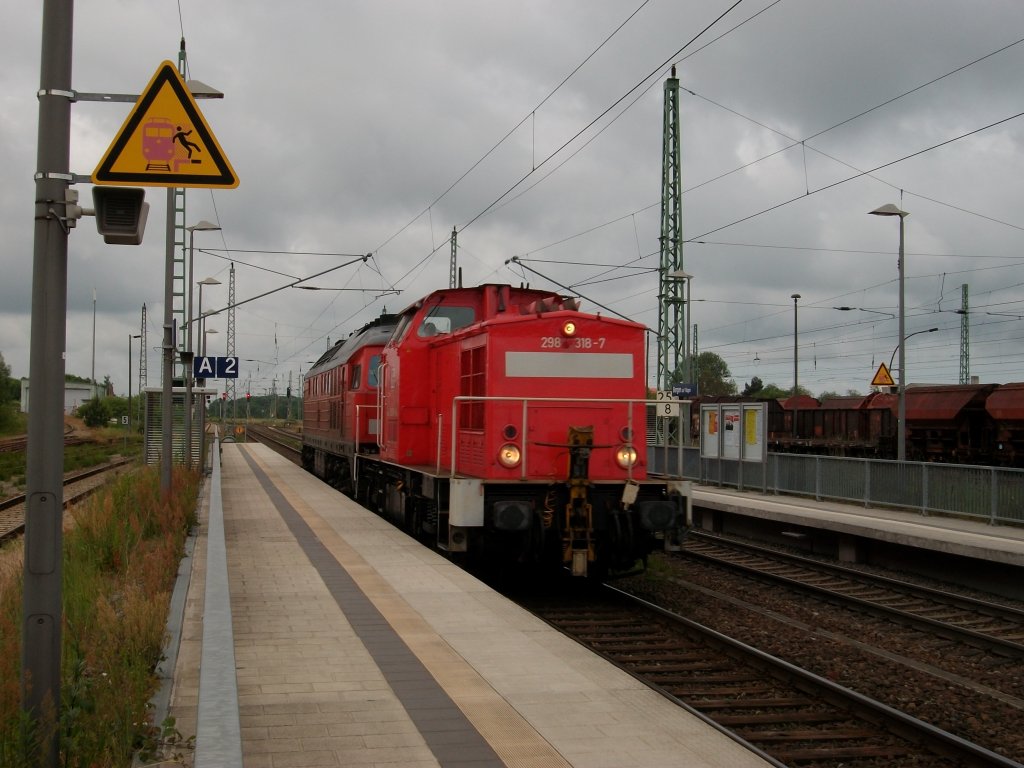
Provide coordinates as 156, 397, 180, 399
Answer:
92, 61, 239, 188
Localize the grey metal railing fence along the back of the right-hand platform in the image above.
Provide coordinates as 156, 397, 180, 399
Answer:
647, 444, 1024, 524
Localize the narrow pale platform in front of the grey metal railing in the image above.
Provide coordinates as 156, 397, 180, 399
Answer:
693, 485, 1024, 567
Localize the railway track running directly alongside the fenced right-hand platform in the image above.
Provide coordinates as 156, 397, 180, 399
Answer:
684, 531, 1024, 662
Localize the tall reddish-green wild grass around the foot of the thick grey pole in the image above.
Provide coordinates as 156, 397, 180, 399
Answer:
0, 468, 199, 768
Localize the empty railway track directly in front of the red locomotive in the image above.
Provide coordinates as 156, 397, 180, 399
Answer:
521, 588, 1020, 768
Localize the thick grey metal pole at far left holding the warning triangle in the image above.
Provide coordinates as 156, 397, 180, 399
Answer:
22, 0, 74, 768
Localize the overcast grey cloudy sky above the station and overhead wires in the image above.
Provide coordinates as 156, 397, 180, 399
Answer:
0, 0, 1024, 403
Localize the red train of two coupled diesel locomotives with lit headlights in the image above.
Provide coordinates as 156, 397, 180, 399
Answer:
303, 285, 685, 575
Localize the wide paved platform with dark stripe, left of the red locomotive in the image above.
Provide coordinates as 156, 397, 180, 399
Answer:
166, 443, 768, 768
